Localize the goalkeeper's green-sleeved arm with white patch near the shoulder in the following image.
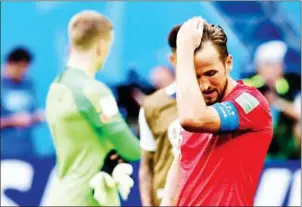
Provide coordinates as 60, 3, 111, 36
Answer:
84, 81, 140, 161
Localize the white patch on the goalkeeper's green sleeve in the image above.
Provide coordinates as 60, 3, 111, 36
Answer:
99, 96, 118, 120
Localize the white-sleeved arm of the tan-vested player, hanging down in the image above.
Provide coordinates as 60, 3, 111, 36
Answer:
138, 108, 156, 206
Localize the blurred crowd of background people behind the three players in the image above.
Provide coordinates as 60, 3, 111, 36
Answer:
1, 41, 301, 159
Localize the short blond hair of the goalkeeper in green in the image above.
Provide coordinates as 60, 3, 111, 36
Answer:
68, 10, 113, 50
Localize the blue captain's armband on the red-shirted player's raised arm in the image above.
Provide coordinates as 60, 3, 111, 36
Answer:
213, 102, 239, 132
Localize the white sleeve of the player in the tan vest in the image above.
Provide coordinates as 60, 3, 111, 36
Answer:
138, 108, 156, 152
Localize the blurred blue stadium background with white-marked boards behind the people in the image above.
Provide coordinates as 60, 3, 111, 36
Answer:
1, 1, 301, 206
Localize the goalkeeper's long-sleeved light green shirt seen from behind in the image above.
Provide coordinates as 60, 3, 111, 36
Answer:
46, 68, 140, 206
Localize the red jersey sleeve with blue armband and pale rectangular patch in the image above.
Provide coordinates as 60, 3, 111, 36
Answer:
213, 92, 271, 132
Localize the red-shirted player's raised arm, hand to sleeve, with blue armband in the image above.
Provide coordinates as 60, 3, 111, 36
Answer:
176, 17, 270, 134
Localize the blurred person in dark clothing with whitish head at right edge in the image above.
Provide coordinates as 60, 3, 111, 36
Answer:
245, 41, 301, 159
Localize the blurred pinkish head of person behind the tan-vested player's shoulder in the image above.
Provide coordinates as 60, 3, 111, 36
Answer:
150, 66, 175, 89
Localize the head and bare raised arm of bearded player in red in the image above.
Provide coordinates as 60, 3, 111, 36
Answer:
176, 17, 236, 133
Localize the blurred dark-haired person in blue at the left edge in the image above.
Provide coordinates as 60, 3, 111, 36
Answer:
0, 47, 44, 158
